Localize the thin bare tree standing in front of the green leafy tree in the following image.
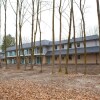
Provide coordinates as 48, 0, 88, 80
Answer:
3, 0, 7, 68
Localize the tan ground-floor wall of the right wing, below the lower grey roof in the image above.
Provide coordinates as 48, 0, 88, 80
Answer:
46, 54, 100, 64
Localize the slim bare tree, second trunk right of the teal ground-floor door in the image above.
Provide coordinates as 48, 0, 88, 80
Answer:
59, 0, 62, 72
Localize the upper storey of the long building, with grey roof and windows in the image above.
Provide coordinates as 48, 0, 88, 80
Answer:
7, 35, 99, 57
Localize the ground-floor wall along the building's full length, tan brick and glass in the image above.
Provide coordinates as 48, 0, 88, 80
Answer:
1, 53, 100, 64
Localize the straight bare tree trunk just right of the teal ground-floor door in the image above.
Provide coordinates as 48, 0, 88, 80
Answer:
52, 0, 55, 73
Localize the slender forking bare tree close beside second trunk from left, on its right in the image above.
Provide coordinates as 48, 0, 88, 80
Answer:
18, 0, 28, 68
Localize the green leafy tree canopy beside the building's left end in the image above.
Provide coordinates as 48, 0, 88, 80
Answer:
1, 34, 15, 51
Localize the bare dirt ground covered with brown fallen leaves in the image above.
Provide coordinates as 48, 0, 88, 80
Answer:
0, 65, 100, 100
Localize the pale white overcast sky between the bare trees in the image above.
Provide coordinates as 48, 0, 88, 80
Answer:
1, 0, 98, 43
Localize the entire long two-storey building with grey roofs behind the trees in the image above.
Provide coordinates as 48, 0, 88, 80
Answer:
1, 35, 100, 64
